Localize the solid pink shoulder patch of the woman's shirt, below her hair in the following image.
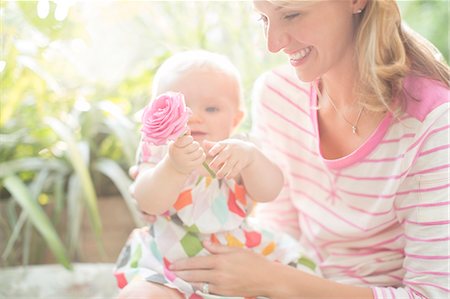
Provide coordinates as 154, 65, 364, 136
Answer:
404, 75, 450, 122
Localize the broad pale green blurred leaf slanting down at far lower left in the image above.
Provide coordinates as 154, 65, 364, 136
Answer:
4, 176, 72, 270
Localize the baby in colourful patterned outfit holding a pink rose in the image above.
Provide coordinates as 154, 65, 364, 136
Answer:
115, 50, 315, 298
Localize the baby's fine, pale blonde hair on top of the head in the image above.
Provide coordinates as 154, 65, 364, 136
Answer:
152, 50, 243, 108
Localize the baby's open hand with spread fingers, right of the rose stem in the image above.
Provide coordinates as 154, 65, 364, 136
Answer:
203, 139, 255, 179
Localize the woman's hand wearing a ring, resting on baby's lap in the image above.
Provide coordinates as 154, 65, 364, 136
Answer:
170, 241, 273, 297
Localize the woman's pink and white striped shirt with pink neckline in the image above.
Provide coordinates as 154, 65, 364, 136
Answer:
252, 67, 450, 298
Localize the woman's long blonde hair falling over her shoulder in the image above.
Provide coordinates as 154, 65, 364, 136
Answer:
355, 0, 450, 113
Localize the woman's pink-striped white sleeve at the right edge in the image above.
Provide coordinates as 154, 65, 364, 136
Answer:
373, 103, 450, 298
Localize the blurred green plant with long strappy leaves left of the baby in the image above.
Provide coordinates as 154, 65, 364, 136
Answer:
0, 101, 144, 267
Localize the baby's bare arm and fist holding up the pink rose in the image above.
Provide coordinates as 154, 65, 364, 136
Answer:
134, 135, 206, 215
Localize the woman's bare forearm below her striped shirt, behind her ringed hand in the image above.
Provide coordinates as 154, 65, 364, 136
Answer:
260, 262, 373, 299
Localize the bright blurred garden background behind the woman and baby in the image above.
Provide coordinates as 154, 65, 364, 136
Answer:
0, 0, 449, 288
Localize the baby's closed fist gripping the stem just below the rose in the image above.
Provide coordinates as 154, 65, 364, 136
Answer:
169, 135, 206, 174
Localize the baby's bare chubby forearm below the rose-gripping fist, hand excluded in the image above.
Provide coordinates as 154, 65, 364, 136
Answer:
134, 157, 189, 215
